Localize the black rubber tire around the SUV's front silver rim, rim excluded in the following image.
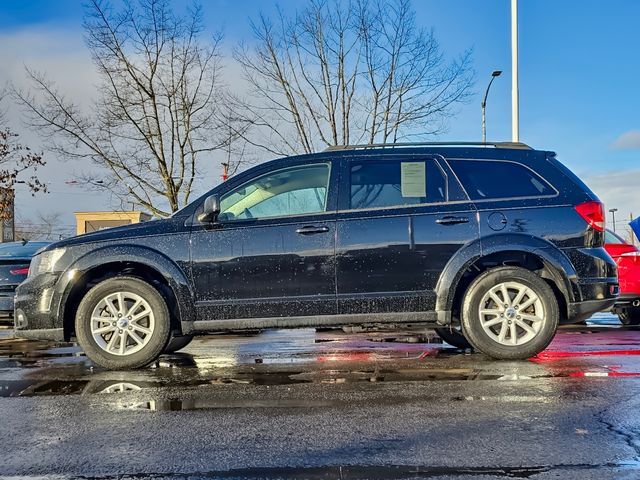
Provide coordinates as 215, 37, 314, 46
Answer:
75, 277, 171, 370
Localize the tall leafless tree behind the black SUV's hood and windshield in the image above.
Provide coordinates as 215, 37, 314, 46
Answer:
14, 0, 226, 216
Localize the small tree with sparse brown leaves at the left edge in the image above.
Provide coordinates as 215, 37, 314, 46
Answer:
0, 92, 47, 220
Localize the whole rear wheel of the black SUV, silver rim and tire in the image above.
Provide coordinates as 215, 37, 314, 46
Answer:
462, 267, 560, 360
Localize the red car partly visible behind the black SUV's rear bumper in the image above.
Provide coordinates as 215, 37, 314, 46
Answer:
604, 230, 640, 325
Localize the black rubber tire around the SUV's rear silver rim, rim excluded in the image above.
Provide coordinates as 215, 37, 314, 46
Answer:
462, 267, 560, 360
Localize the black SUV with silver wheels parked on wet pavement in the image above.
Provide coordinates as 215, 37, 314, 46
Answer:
15, 143, 618, 368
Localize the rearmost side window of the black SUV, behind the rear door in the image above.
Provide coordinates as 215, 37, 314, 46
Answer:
449, 160, 556, 200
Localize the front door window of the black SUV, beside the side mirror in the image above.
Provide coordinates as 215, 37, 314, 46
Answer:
218, 164, 329, 220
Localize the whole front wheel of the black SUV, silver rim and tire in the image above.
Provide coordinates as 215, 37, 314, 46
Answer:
76, 277, 171, 370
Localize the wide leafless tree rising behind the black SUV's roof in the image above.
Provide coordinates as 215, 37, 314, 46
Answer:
234, 0, 474, 154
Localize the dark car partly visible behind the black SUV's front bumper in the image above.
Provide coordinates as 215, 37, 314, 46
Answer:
0, 242, 50, 317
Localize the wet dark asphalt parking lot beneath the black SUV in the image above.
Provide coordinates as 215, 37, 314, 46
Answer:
0, 314, 640, 479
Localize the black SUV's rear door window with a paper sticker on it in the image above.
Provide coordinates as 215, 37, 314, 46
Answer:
350, 159, 447, 209
